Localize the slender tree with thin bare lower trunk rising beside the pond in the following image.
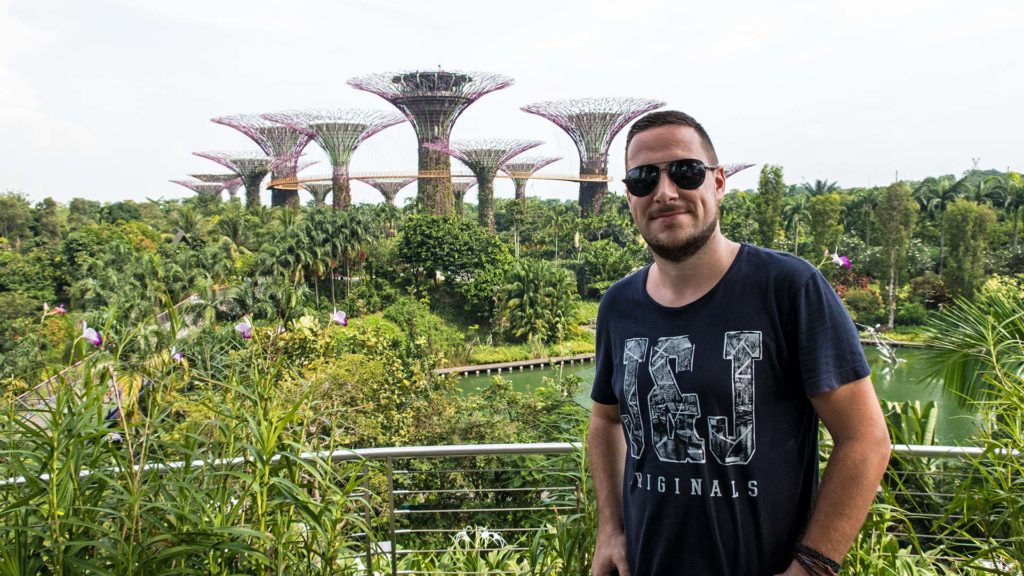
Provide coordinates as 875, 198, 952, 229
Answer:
878, 182, 919, 329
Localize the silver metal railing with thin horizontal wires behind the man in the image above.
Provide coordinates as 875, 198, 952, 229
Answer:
0, 443, 1021, 575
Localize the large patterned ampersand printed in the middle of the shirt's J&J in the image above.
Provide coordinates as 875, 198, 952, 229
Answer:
647, 336, 705, 462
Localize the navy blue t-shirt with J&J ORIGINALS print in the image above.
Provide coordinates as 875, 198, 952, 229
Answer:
591, 244, 869, 576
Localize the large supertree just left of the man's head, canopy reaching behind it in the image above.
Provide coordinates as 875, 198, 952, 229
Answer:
520, 98, 665, 216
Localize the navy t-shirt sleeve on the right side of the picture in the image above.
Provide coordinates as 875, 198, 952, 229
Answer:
792, 271, 871, 396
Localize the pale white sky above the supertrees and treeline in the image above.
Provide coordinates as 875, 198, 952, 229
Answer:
0, 0, 1024, 206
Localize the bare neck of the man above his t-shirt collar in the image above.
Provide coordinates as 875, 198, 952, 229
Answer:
645, 233, 739, 307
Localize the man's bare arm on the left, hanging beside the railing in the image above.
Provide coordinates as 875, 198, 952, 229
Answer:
587, 402, 630, 576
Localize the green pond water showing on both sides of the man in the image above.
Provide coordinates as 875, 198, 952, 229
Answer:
459, 346, 975, 446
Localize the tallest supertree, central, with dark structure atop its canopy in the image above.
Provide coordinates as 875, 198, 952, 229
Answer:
348, 70, 513, 215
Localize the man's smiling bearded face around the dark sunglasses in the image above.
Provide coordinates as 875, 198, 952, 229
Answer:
626, 125, 725, 262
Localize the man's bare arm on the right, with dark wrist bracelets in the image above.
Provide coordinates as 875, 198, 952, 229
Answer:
785, 377, 892, 575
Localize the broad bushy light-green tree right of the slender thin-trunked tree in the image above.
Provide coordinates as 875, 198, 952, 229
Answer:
942, 199, 995, 299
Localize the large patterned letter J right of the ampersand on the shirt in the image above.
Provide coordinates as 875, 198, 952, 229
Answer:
708, 332, 761, 464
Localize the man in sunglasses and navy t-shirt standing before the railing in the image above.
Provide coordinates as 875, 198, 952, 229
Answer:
588, 111, 890, 576
